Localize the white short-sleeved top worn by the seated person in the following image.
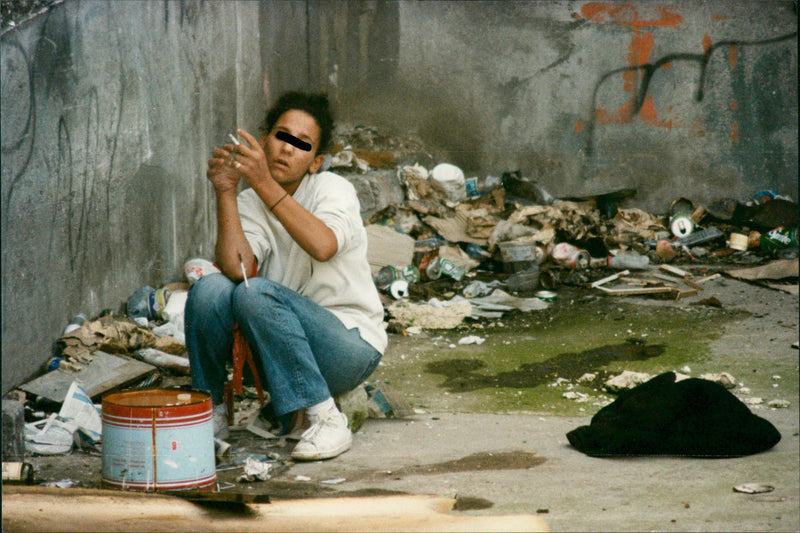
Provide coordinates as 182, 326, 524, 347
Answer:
238, 171, 387, 353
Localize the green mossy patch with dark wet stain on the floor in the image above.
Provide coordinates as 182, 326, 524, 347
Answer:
371, 299, 745, 416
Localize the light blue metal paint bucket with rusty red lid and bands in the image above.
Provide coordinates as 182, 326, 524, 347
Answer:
102, 389, 217, 491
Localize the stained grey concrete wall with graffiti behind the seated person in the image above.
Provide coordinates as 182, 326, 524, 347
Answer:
0, 0, 798, 393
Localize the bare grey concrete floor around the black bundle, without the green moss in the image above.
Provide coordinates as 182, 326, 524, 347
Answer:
12, 266, 800, 531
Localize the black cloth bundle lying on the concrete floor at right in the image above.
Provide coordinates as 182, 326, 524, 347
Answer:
567, 372, 781, 457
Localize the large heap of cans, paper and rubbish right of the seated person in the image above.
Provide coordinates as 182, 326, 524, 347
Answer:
325, 123, 798, 333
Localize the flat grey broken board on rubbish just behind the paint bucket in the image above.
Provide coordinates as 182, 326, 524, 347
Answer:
17, 351, 157, 403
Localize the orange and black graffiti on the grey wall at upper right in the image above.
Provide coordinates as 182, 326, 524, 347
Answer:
575, 2, 797, 156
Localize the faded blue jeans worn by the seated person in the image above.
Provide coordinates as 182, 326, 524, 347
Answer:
184, 274, 381, 416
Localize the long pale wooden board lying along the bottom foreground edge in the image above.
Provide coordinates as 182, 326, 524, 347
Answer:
3, 484, 550, 533
